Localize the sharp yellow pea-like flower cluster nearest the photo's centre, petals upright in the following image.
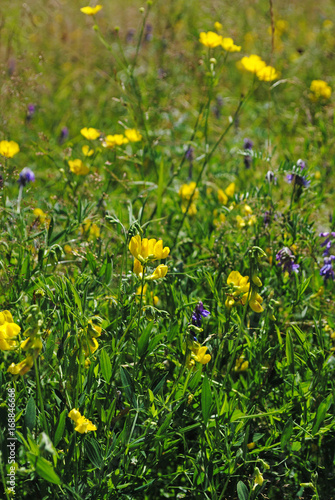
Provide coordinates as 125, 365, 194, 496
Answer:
129, 234, 170, 280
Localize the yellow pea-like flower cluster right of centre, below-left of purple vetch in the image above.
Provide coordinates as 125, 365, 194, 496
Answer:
225, 271, 264, 313
